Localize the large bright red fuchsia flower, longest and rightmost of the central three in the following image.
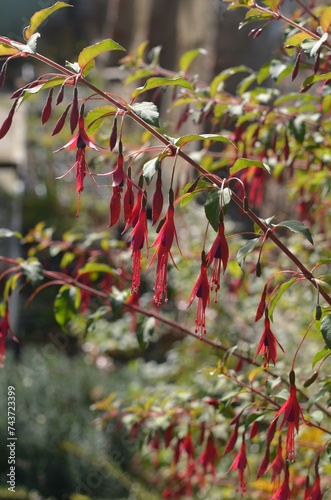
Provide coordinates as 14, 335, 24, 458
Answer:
148, 189, 179, 305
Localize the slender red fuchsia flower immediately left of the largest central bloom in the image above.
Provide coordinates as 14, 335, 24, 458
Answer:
130, 196, 148, 293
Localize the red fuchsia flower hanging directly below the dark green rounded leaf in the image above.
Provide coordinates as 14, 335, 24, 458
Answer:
206, 222, 229, 302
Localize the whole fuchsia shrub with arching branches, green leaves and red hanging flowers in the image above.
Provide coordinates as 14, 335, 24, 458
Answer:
0, 0, 331, 500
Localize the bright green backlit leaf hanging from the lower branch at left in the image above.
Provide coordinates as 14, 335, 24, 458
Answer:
54, 285, 81, 329
